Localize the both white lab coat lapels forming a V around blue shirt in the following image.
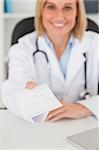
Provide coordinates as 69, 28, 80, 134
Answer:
38, 37, 88, 87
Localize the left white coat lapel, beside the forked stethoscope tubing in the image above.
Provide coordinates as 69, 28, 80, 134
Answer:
38, 37, 64, 84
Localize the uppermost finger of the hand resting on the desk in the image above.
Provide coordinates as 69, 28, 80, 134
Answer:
47, 106, 64, 120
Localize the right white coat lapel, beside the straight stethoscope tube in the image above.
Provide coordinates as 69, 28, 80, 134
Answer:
66, 42, 86, 88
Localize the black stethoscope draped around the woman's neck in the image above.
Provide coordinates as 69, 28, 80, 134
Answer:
33, 37, 91, 99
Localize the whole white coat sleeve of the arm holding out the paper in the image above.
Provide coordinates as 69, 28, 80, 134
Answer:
2, 39, 36, 121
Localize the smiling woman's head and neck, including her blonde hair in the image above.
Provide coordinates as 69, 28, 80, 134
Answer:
35, 0, 86, 58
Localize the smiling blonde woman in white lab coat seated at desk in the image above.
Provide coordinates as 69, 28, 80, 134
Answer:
4, 0, 99, 121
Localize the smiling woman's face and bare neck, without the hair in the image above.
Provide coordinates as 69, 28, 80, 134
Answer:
42, 0, 77, 54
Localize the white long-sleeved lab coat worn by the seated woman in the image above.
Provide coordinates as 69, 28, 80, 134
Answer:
2, 31, 99, 122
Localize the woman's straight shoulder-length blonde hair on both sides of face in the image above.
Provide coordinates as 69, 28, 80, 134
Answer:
35, 0, 87, 40
